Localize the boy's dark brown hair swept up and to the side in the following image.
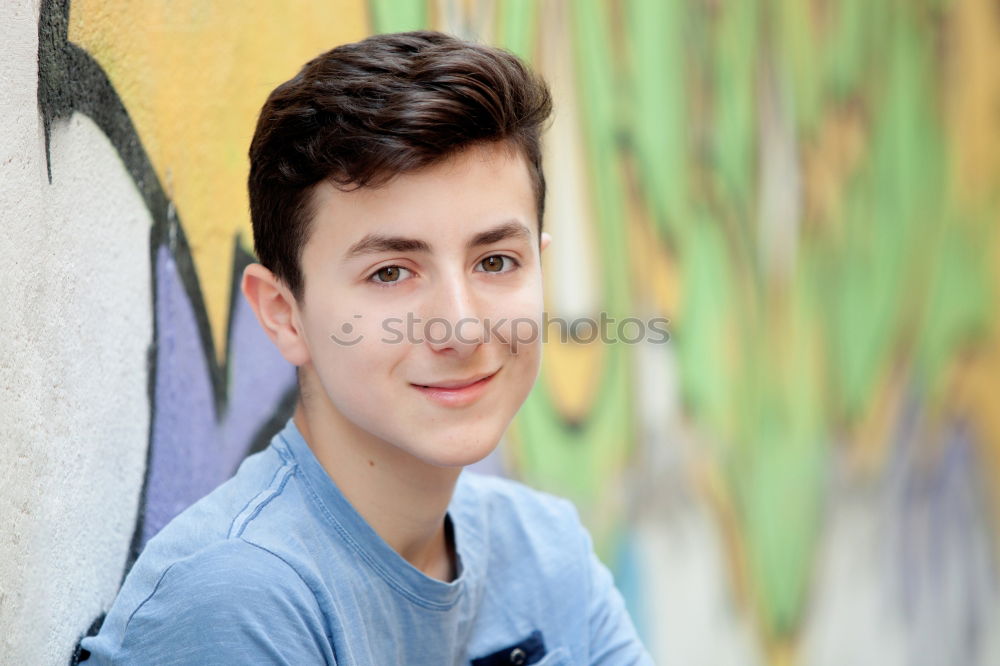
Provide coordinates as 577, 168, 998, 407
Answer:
248, 31, 552, 300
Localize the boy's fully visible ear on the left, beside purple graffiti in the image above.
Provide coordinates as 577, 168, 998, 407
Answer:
240, 264, 309, 365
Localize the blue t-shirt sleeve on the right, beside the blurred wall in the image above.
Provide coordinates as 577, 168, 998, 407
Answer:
574, 500, 653, 666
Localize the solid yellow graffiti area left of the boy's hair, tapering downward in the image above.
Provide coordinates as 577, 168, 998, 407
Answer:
69, 0, 368, 360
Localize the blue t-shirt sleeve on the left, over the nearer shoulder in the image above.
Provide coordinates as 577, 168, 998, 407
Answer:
111, 539, 335, 665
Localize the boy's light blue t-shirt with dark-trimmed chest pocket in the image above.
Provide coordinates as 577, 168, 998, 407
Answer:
81, 419, 652, 666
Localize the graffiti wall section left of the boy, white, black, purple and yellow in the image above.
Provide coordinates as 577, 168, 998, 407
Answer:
0, 1, 367, 663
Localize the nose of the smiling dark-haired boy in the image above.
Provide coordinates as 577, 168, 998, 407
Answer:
423, 275, 484, 357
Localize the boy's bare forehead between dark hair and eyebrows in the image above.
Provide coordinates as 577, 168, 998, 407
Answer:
303, 144, 538, 259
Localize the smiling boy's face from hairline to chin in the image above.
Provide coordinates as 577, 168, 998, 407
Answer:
294, 145, 548, 466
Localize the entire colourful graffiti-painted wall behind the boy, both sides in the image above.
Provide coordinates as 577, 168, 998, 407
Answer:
0, 0, 1000, 665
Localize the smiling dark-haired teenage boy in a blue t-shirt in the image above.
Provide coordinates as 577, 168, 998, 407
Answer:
82, 32, 651, 666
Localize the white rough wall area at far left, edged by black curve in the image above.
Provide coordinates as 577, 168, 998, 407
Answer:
0, 3, 154, 663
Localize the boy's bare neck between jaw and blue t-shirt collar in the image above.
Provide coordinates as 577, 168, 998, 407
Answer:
293, 401, 461, 581
